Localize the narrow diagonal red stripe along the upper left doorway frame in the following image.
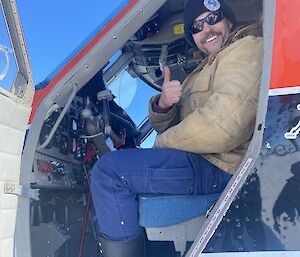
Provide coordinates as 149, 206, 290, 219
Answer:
29, 0, 138, 124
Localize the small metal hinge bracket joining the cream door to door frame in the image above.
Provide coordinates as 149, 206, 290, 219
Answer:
4, 183, 40, 201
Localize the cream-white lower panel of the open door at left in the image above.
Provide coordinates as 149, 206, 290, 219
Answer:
0, 94, 30, 257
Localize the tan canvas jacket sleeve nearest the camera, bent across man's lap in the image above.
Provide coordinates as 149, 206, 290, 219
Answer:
155, 36, 263, 153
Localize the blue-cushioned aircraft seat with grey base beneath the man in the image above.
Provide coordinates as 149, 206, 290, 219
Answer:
139, 194, 220, 256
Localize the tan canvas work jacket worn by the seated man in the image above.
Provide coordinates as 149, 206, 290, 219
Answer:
149, 25, 263, 174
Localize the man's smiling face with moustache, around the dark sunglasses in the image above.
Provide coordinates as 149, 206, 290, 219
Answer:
193, 12, 232, 55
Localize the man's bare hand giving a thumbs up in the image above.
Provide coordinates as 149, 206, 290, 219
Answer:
158, 66, 182, 109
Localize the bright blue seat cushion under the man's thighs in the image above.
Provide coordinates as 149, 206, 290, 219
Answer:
139, 194, 220, 227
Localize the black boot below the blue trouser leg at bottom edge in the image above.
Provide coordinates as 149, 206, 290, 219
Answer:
100, 233, 146, 257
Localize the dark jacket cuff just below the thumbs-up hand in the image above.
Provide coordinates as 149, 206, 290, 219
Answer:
148, 96, 179, 133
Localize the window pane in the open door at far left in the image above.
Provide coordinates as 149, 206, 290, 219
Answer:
0, 8, 18, 91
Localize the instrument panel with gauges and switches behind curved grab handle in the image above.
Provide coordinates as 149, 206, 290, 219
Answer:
33, 96, 94, 190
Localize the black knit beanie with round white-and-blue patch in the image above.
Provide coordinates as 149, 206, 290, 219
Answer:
184, 0, 236, 47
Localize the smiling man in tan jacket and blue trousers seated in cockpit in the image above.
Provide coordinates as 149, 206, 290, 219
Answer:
92, 0, 263, 257
